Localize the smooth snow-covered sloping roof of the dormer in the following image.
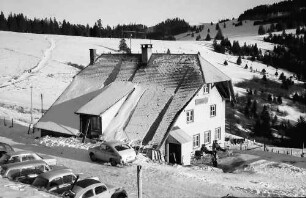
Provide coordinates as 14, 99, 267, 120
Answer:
76, 82, 134, 116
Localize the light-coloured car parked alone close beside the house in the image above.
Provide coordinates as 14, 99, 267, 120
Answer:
89, 141, 136, 166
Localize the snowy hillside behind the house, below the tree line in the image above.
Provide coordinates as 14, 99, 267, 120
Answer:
0, 31, 301, 122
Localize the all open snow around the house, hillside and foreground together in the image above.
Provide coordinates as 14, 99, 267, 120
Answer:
0, 31, 306, 197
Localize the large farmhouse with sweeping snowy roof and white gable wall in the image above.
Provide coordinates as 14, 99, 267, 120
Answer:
34, 44, 234, 165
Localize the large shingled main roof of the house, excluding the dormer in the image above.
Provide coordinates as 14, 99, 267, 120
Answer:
36, 50, 231, 148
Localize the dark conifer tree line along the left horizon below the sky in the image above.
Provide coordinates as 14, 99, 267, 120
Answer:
0, 12, 191, 40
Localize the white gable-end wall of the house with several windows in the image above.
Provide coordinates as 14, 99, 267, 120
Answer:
174, 83, 225, 150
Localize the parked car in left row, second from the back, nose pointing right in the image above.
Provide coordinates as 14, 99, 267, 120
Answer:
0, 151, 57, 166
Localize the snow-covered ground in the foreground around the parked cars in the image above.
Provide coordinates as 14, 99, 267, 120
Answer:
0, 120, 306, 197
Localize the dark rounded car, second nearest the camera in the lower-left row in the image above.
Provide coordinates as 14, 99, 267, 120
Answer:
32, 169, 77, 195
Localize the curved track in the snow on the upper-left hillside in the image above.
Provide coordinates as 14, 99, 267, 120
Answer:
0, 36, 56, 88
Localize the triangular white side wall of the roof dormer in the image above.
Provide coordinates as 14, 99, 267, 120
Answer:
101, 95, 128, 134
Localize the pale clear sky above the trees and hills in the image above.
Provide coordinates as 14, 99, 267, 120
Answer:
0, 0, 281, 27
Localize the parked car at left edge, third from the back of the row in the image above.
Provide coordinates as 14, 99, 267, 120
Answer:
0, 160, 51, 184
